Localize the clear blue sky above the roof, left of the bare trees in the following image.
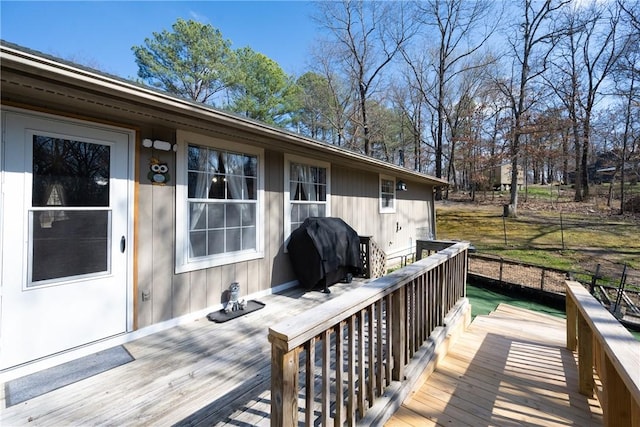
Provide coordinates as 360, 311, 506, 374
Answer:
0, 0, 318, 78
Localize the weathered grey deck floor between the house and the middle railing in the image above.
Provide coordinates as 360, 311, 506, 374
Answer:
0, 281, 361, 426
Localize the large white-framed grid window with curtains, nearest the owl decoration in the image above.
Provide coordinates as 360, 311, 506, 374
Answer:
176, 132, 263, 271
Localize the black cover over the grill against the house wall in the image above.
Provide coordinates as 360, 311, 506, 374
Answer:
287, 217, 362, 289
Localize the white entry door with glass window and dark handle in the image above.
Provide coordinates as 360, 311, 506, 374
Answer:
0, 112, 133, 369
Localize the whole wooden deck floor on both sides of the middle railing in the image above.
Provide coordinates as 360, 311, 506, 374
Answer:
0, 283, 601, 426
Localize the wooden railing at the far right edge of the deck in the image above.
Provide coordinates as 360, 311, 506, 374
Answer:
566, 281, 640, 427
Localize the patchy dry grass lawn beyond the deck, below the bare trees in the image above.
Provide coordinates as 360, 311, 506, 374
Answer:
436, 189, 640, 285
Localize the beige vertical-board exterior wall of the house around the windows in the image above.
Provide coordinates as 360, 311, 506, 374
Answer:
136, 134, 433, 328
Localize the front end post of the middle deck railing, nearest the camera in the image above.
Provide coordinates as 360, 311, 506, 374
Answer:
271, 341, 298, 427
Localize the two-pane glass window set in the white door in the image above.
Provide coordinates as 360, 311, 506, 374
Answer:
28, 135, 112, 287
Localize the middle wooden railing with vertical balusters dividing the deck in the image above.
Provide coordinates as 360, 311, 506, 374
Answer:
269, 242, 469, 426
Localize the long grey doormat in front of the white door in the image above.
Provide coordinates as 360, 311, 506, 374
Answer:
5, 345, 134, 408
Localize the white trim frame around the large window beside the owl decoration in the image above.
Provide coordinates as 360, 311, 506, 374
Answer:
175, 130, 265, 274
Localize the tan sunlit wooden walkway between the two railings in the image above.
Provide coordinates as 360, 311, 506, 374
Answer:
386, 305, 603, 427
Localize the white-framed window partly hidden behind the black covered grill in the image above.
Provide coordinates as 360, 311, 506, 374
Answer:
284, 156, 331, 244
